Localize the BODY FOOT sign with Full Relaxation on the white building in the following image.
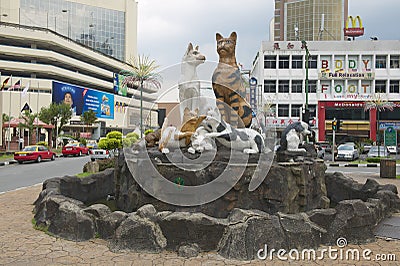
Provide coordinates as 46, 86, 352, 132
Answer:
318, 55, 375, 100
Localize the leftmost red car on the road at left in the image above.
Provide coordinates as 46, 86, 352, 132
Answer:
14, 145, 56, 163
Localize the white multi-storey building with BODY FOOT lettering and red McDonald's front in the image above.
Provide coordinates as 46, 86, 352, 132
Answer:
251, 40, 400, 142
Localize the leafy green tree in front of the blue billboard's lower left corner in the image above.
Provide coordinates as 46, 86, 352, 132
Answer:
39, 103, 72, 148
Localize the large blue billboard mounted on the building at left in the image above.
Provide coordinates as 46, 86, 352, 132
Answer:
52, 81, 114, 119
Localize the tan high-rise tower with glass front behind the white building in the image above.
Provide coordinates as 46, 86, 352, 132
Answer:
270, 0, 348, 41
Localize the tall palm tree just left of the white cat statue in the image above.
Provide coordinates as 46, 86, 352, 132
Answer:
120, 55, 161, 138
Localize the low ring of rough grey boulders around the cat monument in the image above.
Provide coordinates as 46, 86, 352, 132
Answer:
34, 151, 400, 260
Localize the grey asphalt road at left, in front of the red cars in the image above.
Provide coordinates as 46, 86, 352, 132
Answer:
0, 156, 90, 193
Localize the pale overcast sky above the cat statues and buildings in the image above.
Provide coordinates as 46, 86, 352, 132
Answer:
138, 0, 400, 69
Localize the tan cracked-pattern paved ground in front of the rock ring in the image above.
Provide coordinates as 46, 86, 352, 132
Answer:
0, 177, 400, 266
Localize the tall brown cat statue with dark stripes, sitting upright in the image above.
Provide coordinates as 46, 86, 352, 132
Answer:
212, 32, 253, 128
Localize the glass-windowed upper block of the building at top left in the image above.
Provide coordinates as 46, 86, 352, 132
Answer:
4, 0, 137, 61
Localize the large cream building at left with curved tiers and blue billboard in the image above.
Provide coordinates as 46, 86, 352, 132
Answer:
0, 0, 157, 148
